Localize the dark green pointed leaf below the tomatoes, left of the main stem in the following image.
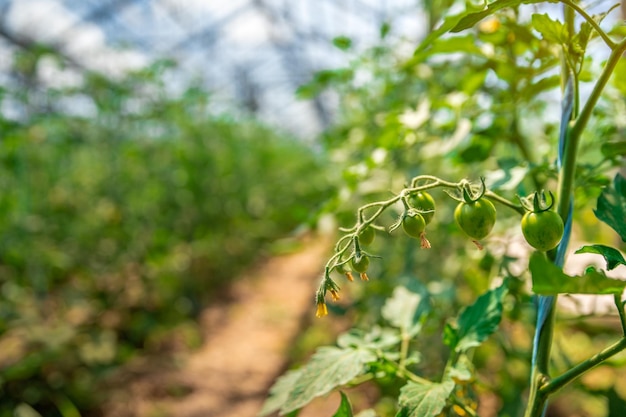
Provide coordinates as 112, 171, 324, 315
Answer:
444, 281, 507, 352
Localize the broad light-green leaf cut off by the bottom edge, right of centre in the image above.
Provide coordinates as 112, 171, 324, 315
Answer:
397, 381, 454, 417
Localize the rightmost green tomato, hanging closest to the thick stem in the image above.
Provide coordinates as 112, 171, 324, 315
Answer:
522, 210, 564, 252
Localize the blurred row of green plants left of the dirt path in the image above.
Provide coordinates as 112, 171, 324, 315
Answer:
0, 47, 328, 416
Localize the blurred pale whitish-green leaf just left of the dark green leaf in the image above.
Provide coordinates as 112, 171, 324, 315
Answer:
382, 286, 429, 337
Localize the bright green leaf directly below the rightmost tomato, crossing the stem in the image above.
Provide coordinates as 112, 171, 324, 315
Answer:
529, 252, 626, 295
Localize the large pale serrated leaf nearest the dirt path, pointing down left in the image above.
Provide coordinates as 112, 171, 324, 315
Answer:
281, 346, 376, 413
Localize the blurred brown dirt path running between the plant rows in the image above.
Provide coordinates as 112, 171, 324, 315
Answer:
105, 239, 344, 417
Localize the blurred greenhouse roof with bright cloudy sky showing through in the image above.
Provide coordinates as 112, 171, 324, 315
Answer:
0, 0, 423, 136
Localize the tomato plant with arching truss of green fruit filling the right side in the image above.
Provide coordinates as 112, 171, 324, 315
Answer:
262, 0, 626, 417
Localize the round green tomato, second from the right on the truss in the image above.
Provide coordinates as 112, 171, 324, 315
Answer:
454, 198, 496, 240
